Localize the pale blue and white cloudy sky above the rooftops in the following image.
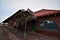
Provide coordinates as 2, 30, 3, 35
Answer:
0, 0, 60, 22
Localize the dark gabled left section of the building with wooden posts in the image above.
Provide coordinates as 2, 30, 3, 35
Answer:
3, 9, 35, 30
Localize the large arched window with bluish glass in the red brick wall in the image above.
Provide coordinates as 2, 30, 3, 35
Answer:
40, 20, 58, 30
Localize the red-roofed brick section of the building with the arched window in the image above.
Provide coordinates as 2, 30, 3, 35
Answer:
34, 9, 60, 36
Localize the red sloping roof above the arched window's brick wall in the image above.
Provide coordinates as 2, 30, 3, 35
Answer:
34, 9, 60, 17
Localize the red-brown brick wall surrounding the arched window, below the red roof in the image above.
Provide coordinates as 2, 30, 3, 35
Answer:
36, 16, 60, 37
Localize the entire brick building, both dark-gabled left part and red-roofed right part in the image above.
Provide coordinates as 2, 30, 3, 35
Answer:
3, 9, 60, 37
